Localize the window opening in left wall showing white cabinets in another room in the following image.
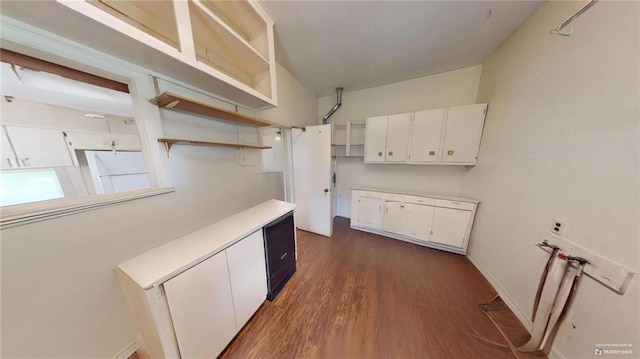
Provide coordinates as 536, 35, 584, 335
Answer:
0, 49, 173, 226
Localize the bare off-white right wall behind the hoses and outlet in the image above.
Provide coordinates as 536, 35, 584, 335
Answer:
463, 1, 640, 358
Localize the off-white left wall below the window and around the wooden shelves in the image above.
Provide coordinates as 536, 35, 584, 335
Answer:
0, 50, 317, 358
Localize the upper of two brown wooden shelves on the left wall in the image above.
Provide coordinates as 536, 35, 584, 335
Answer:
149, 92, 271, 126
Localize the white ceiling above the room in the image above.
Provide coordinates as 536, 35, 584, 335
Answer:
260, 0, 544, 96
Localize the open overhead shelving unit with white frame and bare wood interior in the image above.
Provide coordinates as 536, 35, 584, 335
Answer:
57, 0, 277, 108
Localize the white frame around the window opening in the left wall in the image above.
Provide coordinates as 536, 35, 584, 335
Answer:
0, 15, 175, 229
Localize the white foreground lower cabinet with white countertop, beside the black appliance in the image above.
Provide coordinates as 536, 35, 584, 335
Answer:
118, 200, 295, 358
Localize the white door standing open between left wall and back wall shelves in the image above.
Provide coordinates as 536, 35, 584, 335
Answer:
293, 125, 333, 237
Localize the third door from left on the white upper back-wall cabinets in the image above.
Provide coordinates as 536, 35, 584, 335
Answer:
409, 108, 447, 162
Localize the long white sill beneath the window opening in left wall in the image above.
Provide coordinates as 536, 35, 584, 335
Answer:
0, 187, 175, 229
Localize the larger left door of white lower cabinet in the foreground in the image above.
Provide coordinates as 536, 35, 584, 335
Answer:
163, 252, 237, 358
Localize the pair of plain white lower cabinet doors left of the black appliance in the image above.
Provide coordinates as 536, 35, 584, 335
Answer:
163, 230, 267, 358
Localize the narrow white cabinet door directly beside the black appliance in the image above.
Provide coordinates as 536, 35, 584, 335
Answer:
226, 230, 267, 330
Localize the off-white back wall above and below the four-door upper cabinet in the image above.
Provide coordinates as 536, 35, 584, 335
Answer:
318, 66, 482, 217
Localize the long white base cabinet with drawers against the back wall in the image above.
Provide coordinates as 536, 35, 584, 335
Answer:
351, 189, 479, 254
